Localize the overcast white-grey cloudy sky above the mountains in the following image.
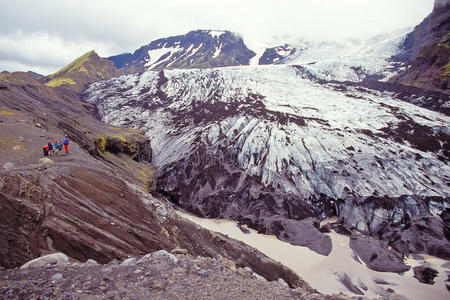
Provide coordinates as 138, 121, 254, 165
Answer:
0, 0, 433, 75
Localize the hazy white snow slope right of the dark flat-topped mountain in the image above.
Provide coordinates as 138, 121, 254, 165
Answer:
252, 29, 411, 81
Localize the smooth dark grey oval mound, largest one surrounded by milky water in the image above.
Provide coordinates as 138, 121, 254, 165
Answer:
350, 235, 410, 273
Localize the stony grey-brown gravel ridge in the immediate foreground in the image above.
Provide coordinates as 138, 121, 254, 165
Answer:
0, 249, 362, 300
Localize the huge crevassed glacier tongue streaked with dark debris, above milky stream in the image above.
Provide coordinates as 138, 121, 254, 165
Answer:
84, 65, 450, 259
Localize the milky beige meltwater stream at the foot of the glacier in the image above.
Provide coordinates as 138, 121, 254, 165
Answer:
178, 211, 450, 300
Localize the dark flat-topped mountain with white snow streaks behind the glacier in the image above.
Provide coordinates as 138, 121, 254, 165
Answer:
108, 30, 255, 73
